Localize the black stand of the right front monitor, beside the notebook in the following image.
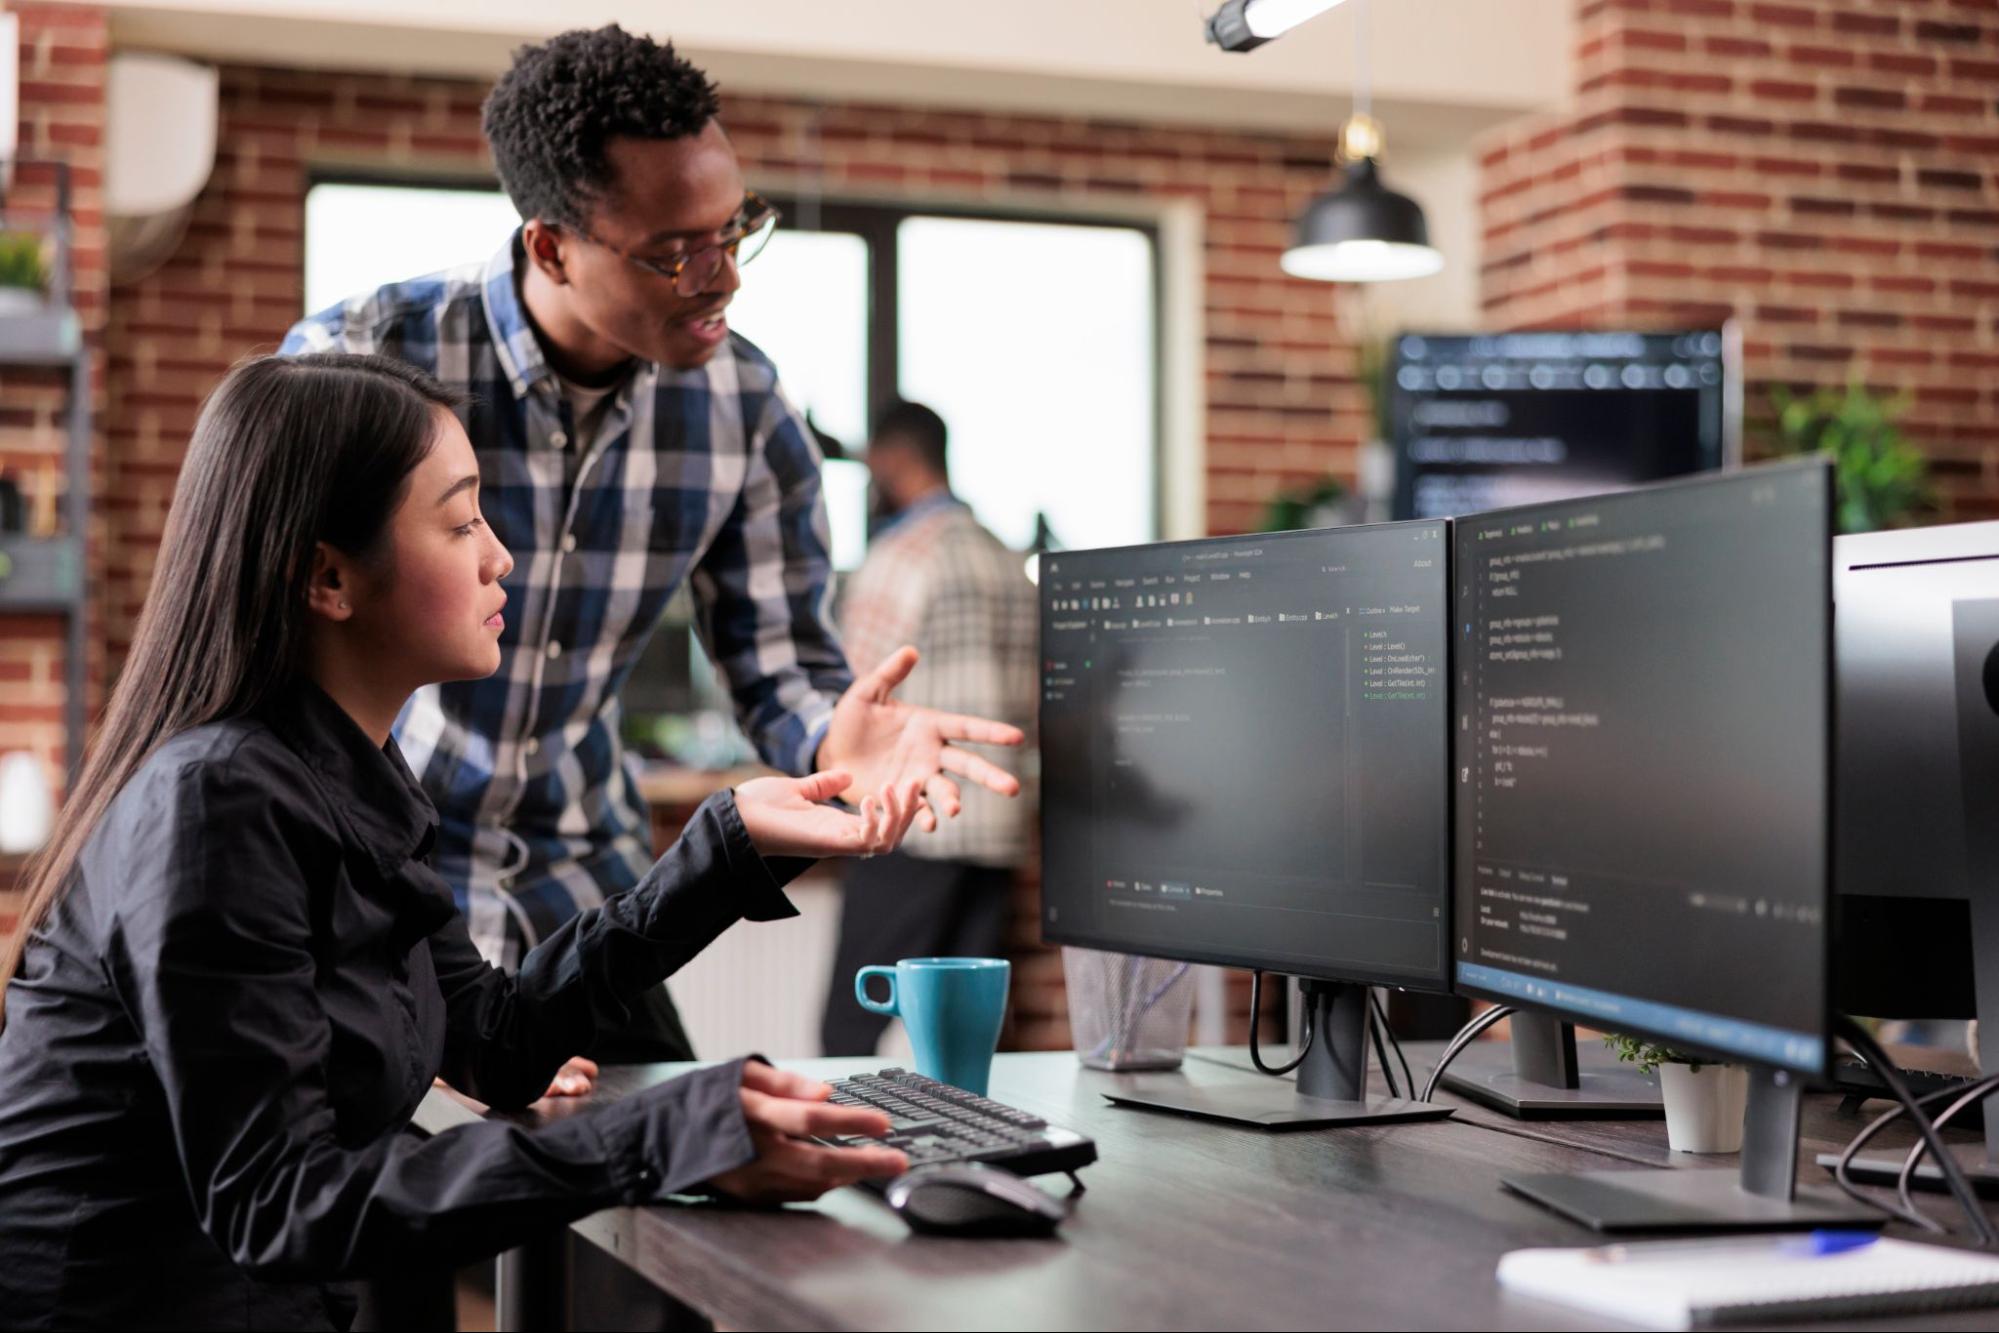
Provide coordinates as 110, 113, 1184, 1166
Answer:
1501, 1065, 1887, 1231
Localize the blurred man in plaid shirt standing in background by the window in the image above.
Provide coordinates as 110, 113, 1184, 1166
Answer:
820, 402, 1039, 1055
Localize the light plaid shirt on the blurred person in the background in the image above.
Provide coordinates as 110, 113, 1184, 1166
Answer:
840, 492, 1041, 865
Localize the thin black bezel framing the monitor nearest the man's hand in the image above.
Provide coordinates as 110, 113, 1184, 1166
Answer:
1035, 518, 1457, 995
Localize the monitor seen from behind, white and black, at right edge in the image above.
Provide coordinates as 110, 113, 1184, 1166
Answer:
1833, 524, 1999, 1179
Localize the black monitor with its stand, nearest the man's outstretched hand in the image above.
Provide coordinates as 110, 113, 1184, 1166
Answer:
1039, 522, 1449, 1125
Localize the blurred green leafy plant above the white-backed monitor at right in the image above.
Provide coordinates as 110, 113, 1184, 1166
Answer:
1771, 382, 1935, 532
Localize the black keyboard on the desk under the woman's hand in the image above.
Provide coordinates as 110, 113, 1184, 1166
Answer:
807, 1069, 1097, 1187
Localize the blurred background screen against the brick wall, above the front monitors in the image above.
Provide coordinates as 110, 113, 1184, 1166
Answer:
1387, 328, 1741, 518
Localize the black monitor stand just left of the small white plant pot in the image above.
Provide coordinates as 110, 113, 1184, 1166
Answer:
1439, 1013, 1665, 1119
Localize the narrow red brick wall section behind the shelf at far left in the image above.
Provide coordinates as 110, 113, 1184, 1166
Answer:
0, 4, 110, 931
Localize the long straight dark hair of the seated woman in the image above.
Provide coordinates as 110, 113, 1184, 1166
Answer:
0, 352, 460, 1023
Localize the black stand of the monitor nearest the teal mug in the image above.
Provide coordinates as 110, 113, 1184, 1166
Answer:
1103, 979, 1451, 1129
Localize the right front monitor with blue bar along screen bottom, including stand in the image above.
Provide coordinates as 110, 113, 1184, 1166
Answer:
1453, 460, 1867, 1229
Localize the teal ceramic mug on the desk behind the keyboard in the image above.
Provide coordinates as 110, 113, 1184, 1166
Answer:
854, 957, 1013, 1097
